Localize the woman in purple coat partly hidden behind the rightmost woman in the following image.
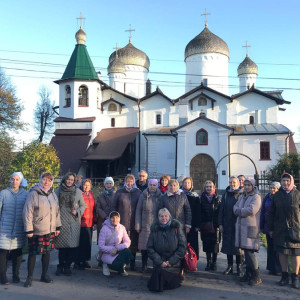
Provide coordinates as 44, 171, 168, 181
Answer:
260, 181, 281, 275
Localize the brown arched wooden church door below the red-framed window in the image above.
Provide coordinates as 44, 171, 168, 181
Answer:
190, 154, 215, 191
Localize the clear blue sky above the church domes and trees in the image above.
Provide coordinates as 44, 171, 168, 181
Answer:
0, 0, 300, 148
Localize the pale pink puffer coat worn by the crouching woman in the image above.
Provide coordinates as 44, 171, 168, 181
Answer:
98, 220, 131, 264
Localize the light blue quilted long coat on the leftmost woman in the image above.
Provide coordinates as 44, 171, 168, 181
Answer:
0, 187, 28, 250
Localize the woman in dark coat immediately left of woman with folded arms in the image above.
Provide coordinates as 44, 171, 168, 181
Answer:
218, 176, 243, 277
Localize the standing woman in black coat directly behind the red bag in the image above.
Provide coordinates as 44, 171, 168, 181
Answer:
182, 177, 200, 260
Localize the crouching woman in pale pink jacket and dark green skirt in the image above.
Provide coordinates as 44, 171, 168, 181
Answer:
98, 211, 133, 276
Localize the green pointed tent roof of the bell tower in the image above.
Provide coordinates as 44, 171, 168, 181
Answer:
61, 44, 98, 80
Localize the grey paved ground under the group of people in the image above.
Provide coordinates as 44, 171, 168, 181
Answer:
0, 233, 300, 300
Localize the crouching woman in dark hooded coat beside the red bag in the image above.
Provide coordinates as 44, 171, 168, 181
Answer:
147, 208, 186, 292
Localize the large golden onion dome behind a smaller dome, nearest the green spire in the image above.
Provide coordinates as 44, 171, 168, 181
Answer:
109, 42, 150, 70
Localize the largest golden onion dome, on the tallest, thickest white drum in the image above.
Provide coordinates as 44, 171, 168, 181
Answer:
185, 25, 229, 59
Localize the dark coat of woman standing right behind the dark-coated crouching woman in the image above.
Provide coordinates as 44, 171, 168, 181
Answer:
158, 190, 192, 229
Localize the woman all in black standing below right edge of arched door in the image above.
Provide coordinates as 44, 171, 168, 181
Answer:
200, 180, 221, 271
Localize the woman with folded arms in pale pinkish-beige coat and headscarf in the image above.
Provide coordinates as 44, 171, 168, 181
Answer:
233, 178, 262, 285
